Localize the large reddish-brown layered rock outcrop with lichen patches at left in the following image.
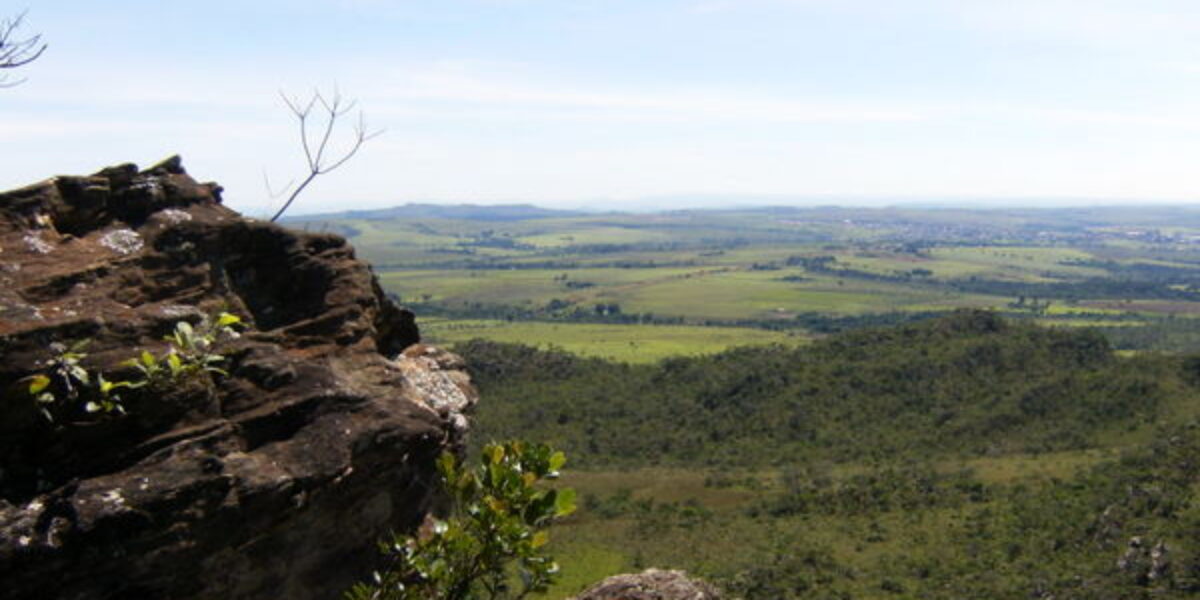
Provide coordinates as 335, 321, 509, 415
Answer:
0, 158, 475, 599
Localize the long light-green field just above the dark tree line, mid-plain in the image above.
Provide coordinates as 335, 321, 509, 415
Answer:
380, 266, 1010, 322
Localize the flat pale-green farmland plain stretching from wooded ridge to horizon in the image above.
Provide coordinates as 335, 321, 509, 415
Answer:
296, 205, 1200, 361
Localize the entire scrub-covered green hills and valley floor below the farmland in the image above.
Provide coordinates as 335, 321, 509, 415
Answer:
457, 311, 1200, 599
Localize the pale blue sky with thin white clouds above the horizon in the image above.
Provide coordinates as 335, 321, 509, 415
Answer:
0, 0, 1200, 215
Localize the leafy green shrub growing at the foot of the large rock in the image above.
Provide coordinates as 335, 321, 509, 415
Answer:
346, 442, 575, 600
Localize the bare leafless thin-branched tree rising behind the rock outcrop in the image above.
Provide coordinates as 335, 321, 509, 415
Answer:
266, 89, 383, 223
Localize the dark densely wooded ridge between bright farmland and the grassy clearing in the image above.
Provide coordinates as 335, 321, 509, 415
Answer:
456, 311, 1195, 467
